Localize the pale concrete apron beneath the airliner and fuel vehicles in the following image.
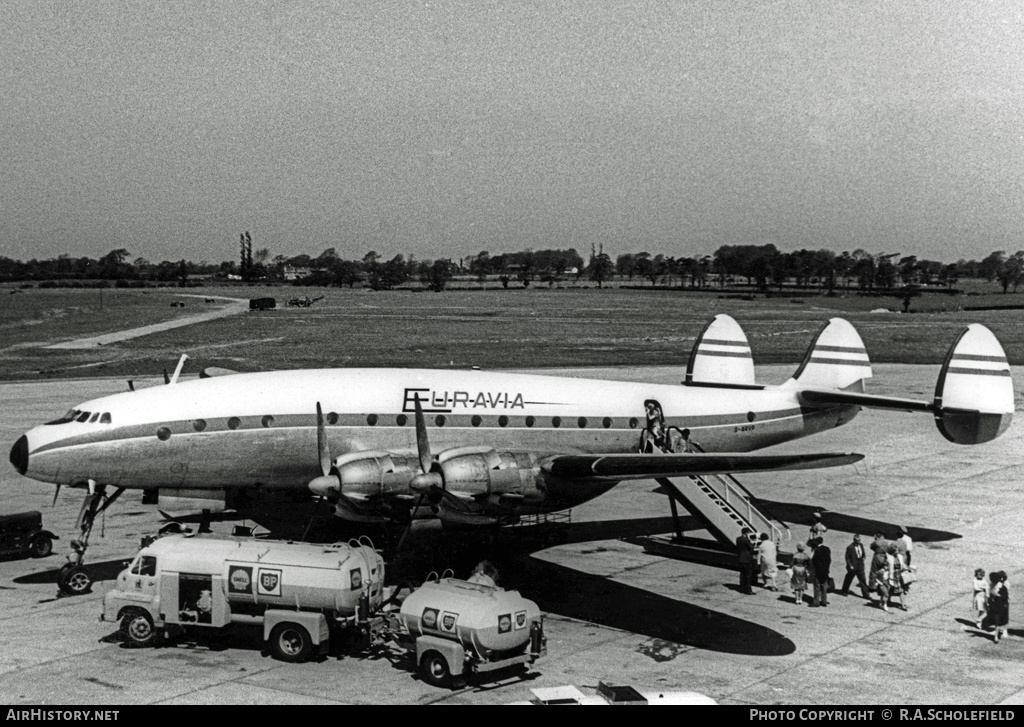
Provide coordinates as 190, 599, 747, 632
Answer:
0, 365, 1024, 705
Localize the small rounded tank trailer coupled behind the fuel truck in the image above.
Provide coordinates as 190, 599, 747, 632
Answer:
388, 578, 548, 687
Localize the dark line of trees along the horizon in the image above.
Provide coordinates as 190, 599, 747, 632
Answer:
6, 244, 1024, 293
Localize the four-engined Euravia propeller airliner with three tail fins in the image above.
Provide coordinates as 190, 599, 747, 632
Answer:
10, 315, 1014, 586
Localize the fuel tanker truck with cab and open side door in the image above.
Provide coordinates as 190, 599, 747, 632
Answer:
101, 534, 384, 661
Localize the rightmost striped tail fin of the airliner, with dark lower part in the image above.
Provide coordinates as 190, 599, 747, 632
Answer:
935, 324, 1014, 444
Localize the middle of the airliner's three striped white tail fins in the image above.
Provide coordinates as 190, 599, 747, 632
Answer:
793, 318, 871, 391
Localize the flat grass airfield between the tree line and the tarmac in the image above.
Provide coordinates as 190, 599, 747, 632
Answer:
0, 287, 1024, 380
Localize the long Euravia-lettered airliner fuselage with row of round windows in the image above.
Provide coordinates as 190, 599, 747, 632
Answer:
11, 369, 857, 509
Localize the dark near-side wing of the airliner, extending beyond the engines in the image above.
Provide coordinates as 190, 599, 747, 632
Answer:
544, 453, 864, 481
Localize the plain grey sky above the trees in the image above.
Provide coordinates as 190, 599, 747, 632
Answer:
0, 0, 1024, 262
